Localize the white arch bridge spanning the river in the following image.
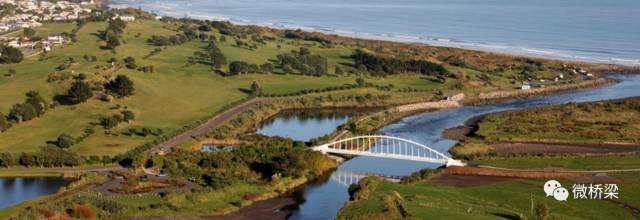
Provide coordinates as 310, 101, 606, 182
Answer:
312, 135, 465, 167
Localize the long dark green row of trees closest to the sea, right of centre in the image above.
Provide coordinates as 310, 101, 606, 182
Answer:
351, 50, 448, 76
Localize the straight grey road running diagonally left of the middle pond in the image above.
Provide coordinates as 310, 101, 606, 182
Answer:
151, 98, 266, 154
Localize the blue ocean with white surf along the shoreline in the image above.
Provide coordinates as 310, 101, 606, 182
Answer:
109, 0, 640, 65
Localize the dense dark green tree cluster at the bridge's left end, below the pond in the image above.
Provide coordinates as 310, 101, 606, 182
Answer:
151, 138, 333, 188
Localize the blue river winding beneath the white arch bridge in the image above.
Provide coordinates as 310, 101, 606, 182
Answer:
252, 75, 640, 219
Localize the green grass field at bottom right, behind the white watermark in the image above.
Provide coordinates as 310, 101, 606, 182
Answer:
338, 173, 640, 219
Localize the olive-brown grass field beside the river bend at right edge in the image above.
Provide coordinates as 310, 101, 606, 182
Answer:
477, 100, 640, 143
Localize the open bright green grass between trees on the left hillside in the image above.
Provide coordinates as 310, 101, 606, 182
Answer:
0, 21, 450, 155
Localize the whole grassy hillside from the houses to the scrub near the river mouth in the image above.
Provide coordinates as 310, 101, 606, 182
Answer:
0, 20, 596, 155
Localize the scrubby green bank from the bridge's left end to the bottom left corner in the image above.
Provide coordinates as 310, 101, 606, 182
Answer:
5, 137, 335, 219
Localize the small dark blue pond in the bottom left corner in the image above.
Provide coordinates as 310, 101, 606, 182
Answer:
0, 177, 69, 209
